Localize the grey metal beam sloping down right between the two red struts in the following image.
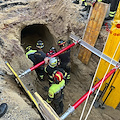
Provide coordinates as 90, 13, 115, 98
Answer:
70, 35, 119, 66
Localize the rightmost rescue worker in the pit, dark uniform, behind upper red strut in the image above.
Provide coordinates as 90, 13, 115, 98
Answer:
58, 39, 70, 82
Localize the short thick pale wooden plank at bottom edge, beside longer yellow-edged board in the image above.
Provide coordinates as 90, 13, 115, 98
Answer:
34, 92, 60, 120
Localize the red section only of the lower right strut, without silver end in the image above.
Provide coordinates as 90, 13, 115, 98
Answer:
72, 68, 116, 109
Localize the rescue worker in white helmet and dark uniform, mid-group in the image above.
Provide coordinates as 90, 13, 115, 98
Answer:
44, 57, 67, 86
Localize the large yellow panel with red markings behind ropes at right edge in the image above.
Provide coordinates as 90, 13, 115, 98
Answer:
95, 4, 120, 108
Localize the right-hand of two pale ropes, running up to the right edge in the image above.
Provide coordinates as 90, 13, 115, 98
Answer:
85, 42, 120, 120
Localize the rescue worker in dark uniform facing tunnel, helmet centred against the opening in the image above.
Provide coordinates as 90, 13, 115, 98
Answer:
34, 40, 46, 81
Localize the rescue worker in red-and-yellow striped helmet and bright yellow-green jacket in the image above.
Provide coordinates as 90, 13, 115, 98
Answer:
47, 70, 65, 115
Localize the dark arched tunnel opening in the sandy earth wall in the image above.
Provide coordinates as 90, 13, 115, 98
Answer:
21, 24, 55, 52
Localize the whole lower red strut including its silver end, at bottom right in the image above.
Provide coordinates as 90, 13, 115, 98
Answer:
60, 65, 120, 120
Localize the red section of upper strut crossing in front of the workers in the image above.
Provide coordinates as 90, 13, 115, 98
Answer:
30, 43, 75, 71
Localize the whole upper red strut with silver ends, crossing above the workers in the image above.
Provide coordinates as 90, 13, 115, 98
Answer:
18, 40, 81, 77
